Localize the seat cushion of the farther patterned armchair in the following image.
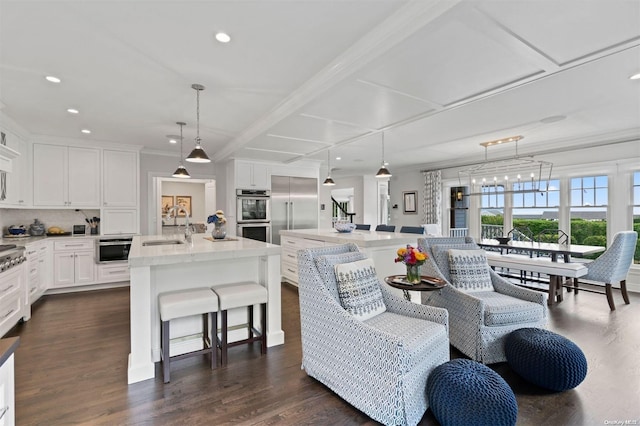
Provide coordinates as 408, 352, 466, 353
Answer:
473, 291, 545, 327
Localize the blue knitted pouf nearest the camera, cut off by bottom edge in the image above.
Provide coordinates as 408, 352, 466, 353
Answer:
427, 359, 518, 426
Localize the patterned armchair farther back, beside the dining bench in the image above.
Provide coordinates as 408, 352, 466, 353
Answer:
418, 237, 547, 364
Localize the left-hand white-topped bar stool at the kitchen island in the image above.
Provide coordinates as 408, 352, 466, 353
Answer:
158, 287, 218, 383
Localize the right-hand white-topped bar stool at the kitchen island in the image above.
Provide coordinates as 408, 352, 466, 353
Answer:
211, 281, 268, 365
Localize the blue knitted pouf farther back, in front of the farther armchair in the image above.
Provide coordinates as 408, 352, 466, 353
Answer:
505, 328, 587, 391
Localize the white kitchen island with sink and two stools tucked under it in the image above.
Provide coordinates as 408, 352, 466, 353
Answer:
128, 234, 284, 383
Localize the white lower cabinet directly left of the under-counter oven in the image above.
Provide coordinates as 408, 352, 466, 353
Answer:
52, 238, 96, 287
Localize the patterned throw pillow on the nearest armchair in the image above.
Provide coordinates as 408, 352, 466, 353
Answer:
335, 259, 387, 321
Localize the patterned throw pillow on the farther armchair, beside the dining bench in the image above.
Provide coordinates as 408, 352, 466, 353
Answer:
449, 249, 493, 292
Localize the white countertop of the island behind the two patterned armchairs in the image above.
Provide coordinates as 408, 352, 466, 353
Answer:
280, 228, 425, 248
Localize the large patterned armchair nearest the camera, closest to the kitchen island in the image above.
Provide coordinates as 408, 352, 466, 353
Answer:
298, 244, 449, 425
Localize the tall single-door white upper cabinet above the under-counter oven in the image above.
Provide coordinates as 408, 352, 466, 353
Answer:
102, 149, 140, 207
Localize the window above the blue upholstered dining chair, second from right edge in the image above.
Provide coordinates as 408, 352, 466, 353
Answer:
570, 176, 609, 251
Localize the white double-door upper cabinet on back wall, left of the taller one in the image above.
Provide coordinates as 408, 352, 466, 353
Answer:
33, 144, 100, 208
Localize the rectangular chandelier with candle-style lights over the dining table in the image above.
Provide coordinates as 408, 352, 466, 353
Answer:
458, 135, 553, 195
